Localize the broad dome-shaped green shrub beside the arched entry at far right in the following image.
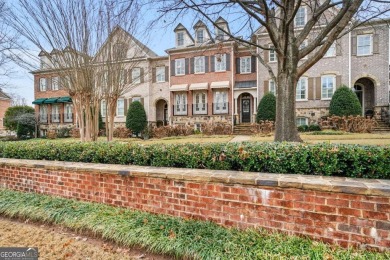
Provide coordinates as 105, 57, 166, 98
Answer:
329, 86, 362, 116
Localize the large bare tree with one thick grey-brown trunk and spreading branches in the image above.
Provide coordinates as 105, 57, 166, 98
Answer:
155, 0, 390, 141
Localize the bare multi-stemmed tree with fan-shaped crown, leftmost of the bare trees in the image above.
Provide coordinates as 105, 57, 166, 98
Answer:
7, 0, 146, 141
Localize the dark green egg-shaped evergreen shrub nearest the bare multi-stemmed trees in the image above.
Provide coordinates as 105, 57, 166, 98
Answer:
126, 101, 148, 136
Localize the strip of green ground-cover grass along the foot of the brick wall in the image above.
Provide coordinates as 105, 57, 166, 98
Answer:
0, 189, 390, 259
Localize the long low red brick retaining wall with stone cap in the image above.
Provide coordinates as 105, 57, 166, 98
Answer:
0, 159, 390, 250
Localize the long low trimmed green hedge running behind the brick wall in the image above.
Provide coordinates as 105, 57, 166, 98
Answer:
0, 141, 390, 179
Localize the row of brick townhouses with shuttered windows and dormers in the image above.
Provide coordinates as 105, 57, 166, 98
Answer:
33, 14, 390, 134
